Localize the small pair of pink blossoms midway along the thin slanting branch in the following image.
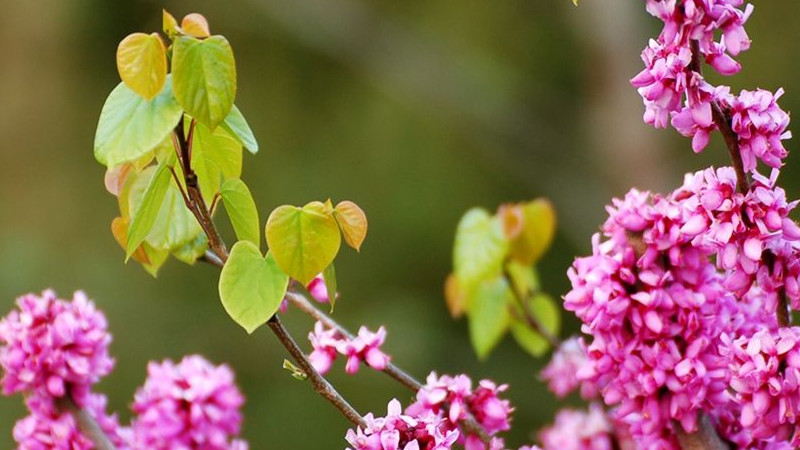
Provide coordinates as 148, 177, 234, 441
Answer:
308, 321, 389, 375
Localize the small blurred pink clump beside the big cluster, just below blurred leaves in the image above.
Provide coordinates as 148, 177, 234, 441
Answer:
541, 336, 600, 400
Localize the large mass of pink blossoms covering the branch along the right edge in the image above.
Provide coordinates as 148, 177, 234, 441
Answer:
542, 0, 800, 449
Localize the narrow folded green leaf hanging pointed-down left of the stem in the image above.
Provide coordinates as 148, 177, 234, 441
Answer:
125, 164, 170, 261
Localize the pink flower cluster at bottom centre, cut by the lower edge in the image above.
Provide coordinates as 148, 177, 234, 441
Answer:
347, 373, 513, 450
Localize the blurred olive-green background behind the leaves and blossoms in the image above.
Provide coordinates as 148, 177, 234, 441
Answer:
0, 0, 800, 449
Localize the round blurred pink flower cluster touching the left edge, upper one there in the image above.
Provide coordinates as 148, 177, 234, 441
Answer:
0, 290, 114, 406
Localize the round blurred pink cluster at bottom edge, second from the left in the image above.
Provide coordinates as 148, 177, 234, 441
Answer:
132, 356, 246, 450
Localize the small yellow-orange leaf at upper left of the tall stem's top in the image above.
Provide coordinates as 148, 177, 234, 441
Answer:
117, 33, 167, 100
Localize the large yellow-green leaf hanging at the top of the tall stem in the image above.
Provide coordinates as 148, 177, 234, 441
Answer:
172, 36, 236, 130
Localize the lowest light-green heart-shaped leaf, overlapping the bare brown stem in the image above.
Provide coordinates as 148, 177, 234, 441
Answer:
219, 241, 289, 333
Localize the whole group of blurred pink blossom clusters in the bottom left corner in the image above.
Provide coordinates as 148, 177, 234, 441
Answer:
0, 291, 248, 450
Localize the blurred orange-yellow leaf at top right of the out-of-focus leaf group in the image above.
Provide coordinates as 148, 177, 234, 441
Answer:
510, 199, 556, 265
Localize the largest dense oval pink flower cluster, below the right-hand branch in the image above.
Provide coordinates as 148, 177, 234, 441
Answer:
564, 190, 738, 448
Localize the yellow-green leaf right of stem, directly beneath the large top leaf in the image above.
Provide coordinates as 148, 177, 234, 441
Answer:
192, 123, 242, 204
